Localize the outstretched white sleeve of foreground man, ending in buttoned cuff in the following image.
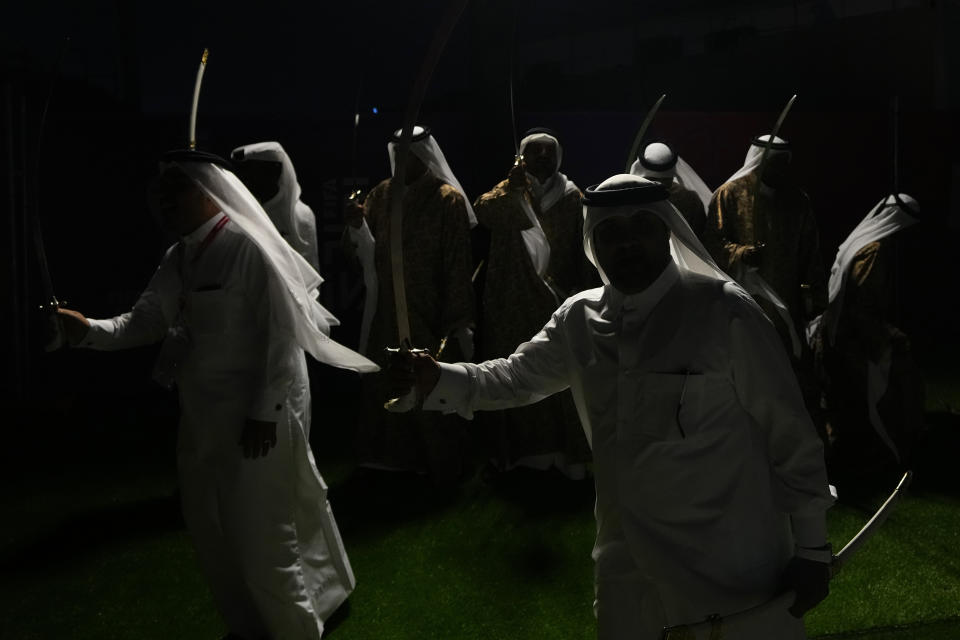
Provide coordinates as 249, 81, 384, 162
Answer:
423, 309, 570, 419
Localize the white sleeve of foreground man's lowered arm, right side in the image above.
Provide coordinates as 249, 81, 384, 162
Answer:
727, 285, 833, 547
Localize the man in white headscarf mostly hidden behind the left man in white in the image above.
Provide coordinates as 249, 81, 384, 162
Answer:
230, 142, 320, 271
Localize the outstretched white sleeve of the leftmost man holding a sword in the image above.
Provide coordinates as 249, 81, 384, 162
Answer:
78, 245, 181, 351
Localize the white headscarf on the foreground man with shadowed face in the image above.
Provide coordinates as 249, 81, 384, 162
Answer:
583, 173, 733, 285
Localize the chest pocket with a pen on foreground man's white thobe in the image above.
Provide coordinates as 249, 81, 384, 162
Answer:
620, 373, 707, 441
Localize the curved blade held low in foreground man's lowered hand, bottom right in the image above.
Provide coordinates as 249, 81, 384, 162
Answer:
661, 471, 913, 640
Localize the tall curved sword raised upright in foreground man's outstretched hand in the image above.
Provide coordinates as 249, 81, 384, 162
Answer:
385, 0, 469, 410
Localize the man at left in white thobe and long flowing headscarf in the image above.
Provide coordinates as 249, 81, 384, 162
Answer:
59, 151, 375, 640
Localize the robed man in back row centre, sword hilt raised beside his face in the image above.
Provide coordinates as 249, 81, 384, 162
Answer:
474, 128, 596, 479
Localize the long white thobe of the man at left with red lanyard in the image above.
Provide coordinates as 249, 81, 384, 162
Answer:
82, 213, 355, 640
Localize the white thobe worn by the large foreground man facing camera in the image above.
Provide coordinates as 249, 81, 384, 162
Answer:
424, 262, 832, 640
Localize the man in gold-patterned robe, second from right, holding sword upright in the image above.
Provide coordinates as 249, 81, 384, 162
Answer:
703, 135, 827, 360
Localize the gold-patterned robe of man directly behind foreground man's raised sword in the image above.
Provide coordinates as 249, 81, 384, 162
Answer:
357, 173, 475, 484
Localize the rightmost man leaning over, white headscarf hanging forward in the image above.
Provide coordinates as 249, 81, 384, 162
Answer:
808, 193, 923, 477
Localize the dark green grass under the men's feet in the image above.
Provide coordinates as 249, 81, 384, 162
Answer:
0, 368, 960, 640
